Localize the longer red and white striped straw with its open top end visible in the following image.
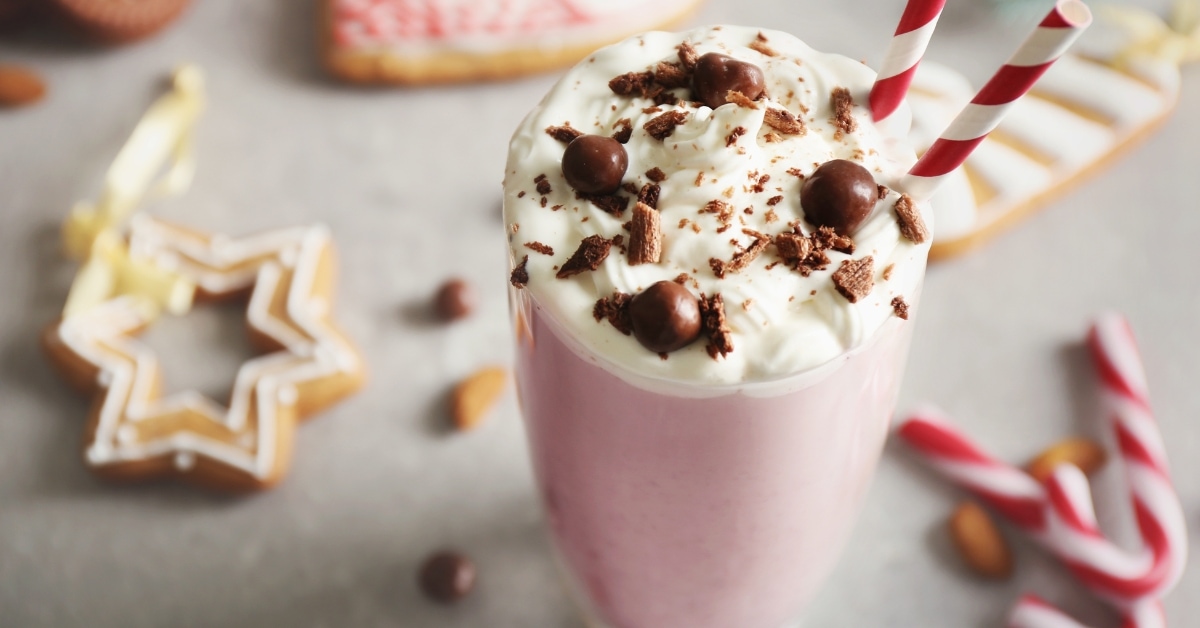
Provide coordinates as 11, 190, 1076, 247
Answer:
901, 0, 1092, 199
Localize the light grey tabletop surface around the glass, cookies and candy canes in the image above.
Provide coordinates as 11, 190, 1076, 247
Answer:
0, 0, 1200, 627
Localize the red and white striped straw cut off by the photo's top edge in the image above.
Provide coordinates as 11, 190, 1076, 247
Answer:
870, 0, 946, 122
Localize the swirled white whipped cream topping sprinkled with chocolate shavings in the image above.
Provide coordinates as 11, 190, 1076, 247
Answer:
504, 26, 932, 387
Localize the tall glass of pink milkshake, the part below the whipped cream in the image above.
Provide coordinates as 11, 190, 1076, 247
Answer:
510, 285, 916, 628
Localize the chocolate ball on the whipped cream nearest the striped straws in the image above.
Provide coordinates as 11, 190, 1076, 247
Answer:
800, 160, 880, 235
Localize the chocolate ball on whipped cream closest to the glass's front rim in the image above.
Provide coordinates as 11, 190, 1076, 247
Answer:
629, 281, 700, 353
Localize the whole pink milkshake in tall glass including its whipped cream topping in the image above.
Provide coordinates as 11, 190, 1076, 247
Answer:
505, 26, 930, 628
